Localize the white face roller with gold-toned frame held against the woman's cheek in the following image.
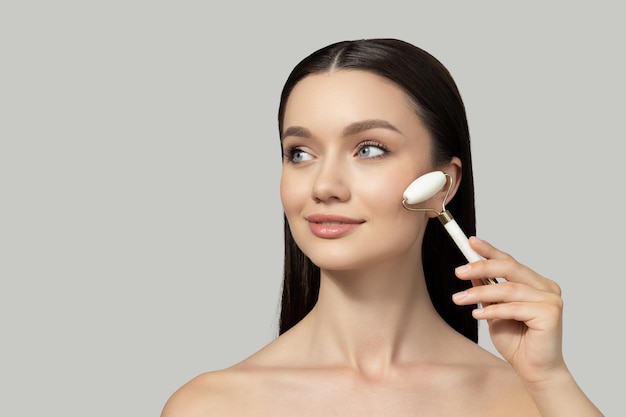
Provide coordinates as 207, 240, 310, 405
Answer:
402, 171, 498, 284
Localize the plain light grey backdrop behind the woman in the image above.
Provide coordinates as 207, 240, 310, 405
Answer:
0, 0, 626, 417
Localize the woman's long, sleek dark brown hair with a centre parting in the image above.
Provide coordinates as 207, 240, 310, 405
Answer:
278, 39, 478, 342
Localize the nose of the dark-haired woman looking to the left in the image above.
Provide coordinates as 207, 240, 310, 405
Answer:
311, 158, 350, 203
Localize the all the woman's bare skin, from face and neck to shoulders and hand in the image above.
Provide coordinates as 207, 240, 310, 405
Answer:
162, 70, 602, 417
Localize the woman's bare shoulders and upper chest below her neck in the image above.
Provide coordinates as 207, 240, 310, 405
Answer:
163, 298, 539, 417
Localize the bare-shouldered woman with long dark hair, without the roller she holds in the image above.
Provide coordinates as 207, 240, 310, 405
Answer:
162, 39, 602, 417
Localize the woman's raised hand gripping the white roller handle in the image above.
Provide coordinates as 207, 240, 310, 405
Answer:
453, 237, 568, 386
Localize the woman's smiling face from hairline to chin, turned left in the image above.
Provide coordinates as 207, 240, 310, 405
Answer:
280, 70, 433, 270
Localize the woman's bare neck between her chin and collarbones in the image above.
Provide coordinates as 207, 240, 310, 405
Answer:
305, 263, 449, 377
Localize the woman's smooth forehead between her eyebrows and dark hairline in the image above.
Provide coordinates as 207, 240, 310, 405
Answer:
283, 70, 423, 130
